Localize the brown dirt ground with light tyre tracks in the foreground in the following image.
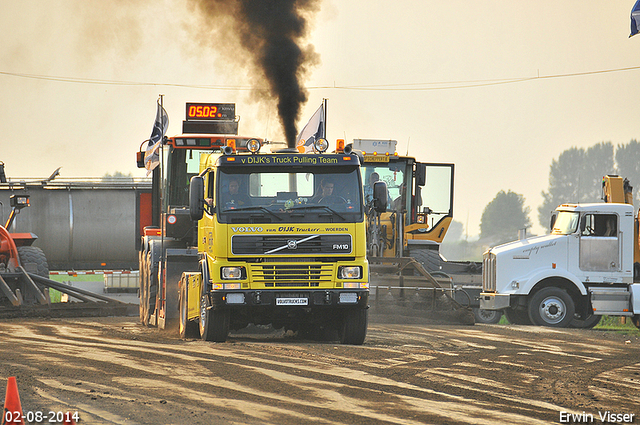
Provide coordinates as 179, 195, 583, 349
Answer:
0, 317, 640, 425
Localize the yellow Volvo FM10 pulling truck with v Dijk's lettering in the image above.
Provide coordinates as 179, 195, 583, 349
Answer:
180, 139, 369, 344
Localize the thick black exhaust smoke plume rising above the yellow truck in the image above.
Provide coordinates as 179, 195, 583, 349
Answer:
192, 0, 320, 147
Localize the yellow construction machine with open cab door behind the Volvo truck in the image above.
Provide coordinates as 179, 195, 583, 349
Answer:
350, 139, 480, 323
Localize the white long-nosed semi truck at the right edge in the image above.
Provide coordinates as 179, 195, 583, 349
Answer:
480, 176, 640, 328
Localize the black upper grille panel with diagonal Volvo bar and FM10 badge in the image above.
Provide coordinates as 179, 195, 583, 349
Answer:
231, 234, 352, 256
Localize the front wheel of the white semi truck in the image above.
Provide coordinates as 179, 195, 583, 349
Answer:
529, 287, 576, 328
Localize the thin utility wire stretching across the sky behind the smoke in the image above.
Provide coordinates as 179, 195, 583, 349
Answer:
0, 66, 640, 91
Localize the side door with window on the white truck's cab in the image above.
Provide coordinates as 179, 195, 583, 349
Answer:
580, 214, 620, 272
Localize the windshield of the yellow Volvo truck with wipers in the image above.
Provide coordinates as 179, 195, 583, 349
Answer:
215, 167, 363, 223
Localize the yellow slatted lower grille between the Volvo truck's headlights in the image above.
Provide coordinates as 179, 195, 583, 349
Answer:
250, 263, 333, 288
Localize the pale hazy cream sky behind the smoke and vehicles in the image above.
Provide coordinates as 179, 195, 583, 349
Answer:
0, 0, 640, 238
